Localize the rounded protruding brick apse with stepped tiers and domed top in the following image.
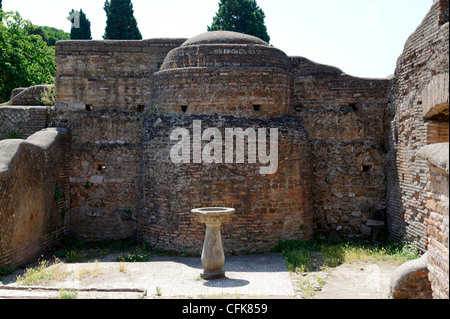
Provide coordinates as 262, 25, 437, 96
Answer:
139, 33, 313, 253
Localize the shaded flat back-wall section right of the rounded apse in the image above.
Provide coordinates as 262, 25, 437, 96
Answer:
291, 57, 389, 236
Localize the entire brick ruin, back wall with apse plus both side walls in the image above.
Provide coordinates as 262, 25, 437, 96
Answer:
0, 0, 449, 298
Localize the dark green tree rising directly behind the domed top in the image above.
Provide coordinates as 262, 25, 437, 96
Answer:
208, 0, 270, 43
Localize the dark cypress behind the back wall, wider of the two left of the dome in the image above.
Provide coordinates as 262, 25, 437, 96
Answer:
103, 0, 142, 40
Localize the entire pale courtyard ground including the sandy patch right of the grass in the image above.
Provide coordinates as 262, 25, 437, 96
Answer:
0, 254, 397, 299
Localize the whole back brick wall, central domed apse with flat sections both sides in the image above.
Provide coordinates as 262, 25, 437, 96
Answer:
55, 31, 389, 252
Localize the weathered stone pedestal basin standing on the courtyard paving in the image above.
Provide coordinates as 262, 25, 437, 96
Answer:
191, 207, 234, 280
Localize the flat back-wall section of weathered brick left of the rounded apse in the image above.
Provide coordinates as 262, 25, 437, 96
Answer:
55, 39, 184, 240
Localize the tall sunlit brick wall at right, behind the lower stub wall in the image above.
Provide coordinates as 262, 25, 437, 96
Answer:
387, 1, 449, 251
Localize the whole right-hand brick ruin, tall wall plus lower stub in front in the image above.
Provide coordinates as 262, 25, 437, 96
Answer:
386, 1, 449, 298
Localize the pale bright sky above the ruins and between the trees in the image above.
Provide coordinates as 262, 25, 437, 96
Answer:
3, 0, 433, 77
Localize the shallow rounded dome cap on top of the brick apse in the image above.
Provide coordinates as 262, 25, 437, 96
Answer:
181, 31, 269, 46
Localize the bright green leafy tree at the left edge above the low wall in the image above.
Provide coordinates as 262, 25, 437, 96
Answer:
0, 11, 55, 101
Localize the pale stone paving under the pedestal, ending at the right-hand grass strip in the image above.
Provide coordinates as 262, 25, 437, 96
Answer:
0, 254, 296, 299
